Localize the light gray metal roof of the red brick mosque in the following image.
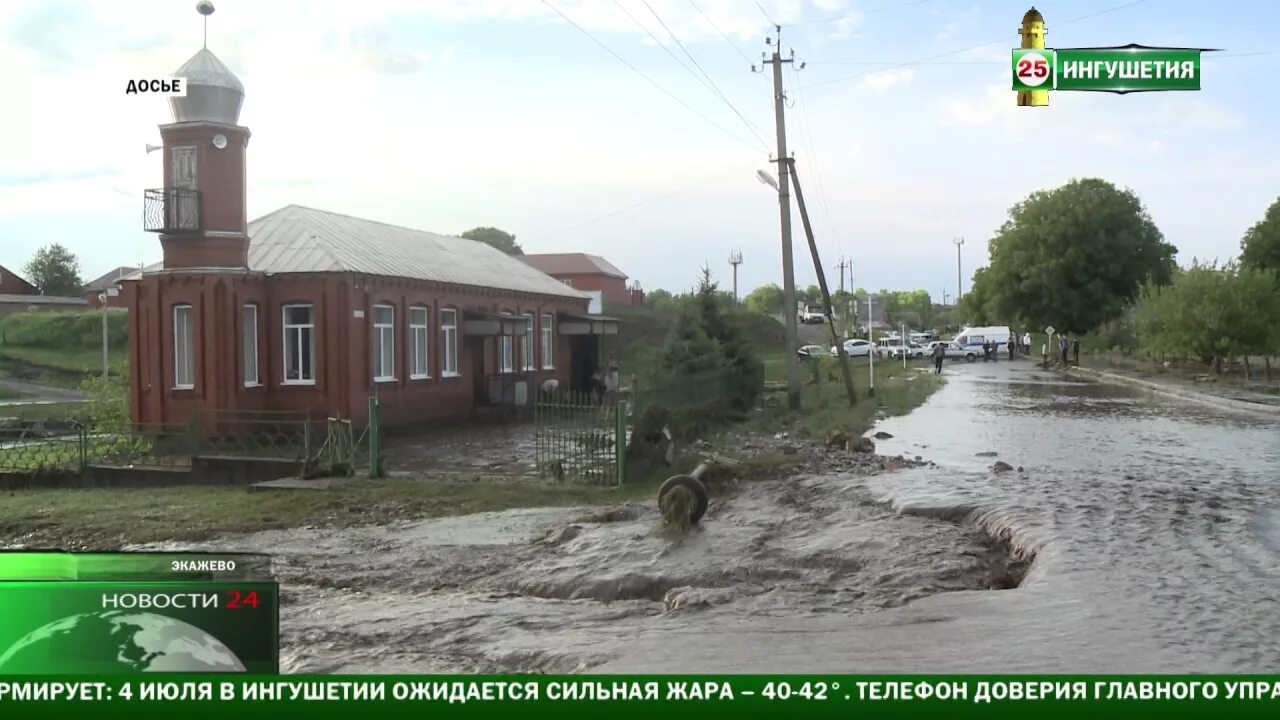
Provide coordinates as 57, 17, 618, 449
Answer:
248, 205, 588, 299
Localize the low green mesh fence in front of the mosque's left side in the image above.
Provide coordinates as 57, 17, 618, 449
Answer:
0, 410, 380, 475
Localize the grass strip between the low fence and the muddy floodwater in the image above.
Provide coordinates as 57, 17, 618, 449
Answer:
0, 478, 657, 550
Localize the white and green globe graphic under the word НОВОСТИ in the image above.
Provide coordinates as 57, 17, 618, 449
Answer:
0, 610, 244, 674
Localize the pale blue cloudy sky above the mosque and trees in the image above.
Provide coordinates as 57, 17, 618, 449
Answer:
0, 0, 1280, 300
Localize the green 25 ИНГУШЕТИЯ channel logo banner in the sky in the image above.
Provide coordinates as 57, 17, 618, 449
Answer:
1012, 45, 1213, 95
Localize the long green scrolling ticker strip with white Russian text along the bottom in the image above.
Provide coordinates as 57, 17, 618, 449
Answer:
0, 675, 1280, 720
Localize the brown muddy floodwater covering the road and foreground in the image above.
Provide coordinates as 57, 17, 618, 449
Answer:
142, 361, 1280, 673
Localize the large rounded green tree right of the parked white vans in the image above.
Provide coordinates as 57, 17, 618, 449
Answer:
977, 178, 1176, 333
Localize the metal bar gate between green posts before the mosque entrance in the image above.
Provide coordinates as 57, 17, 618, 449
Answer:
534, 392, 627, 486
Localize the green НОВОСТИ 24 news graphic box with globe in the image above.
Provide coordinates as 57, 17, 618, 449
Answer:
0, 551, 280, 675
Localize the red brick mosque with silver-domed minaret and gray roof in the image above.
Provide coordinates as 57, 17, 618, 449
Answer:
122, 39, 617, 424
